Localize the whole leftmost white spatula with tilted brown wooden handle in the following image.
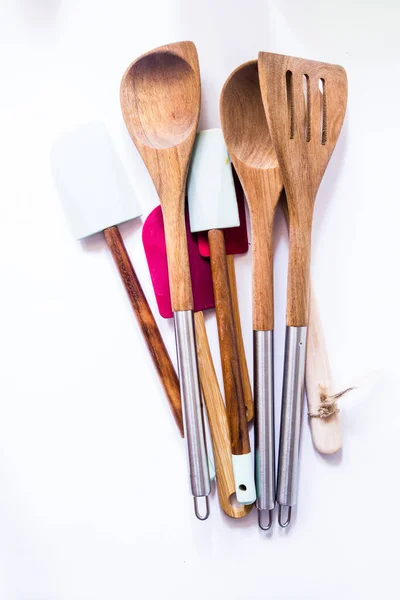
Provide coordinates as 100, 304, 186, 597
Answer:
52, 121, 183, 435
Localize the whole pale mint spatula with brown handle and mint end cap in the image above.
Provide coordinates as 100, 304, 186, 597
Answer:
188, 129, 256, 504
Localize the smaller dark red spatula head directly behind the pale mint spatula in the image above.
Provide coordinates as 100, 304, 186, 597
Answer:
197, 167, 249, 258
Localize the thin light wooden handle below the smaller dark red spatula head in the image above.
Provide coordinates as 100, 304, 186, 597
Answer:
226, 254, 254, 422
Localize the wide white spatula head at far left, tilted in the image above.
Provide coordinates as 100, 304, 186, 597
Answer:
52, 121, 141, 240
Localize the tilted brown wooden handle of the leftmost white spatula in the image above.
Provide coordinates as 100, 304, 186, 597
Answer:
104, 227, 183, 437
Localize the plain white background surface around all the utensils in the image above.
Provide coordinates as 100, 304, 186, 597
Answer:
0, 0, 400, 600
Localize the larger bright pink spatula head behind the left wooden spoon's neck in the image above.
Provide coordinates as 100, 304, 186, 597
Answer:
142, 206, 215, 319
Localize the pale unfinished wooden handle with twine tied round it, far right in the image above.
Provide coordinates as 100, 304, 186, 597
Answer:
306, 287, 342, 454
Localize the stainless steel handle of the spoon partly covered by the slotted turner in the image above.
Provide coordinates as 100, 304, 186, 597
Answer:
253, 331, 275, 530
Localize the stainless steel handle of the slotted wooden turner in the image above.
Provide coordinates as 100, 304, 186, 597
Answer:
276, 327, 307, 527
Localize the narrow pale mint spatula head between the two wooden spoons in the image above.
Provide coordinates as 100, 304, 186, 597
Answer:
188, 129, 240, 232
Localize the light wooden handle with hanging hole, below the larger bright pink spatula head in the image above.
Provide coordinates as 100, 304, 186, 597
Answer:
194, 312, 253, 519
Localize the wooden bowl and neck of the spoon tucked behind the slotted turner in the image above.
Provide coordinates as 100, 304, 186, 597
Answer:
220, 60, 282, 331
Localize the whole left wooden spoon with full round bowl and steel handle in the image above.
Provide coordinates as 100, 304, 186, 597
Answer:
121, 42, 210, 518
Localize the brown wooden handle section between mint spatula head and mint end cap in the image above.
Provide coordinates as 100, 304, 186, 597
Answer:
208, 229, 250, 455
